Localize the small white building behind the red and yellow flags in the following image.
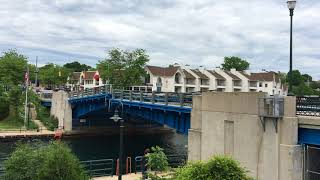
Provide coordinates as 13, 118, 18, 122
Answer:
67, 71, 105, 89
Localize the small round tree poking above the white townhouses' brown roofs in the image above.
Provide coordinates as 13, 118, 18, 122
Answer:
221, 56, 250, 71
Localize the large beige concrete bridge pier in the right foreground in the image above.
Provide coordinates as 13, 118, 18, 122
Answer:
188, 92, 302, 180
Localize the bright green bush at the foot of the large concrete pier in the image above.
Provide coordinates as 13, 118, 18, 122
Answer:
174, 156, 251, 180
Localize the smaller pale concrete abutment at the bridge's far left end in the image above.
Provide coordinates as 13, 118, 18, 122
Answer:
50, 91, 72, 131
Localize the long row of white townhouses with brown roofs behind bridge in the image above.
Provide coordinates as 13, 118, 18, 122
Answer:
145, 65, 287, 95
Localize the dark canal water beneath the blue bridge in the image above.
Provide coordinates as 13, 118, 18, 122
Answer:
0, 132, 187, 160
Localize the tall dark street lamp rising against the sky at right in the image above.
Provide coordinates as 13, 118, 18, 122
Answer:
287, 0, 296, 96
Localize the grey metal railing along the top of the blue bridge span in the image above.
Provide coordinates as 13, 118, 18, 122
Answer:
69, 85, 200, 107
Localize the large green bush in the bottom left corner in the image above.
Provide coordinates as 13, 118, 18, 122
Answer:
4, 142, 89, 180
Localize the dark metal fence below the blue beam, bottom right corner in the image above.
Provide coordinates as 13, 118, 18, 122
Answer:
304, 145, 320, 180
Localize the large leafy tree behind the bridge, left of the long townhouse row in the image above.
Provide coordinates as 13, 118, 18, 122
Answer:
97, 49, 149, 88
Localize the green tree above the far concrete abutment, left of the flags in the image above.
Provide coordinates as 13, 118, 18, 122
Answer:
39, 63, 70, 86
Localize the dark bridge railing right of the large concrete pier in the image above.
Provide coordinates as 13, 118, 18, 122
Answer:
296, 96, 320, 116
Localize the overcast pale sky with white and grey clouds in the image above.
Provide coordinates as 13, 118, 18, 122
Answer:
0, 0, 320, 79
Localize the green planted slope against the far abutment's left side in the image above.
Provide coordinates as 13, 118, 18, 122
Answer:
37, 106, 58, 131
